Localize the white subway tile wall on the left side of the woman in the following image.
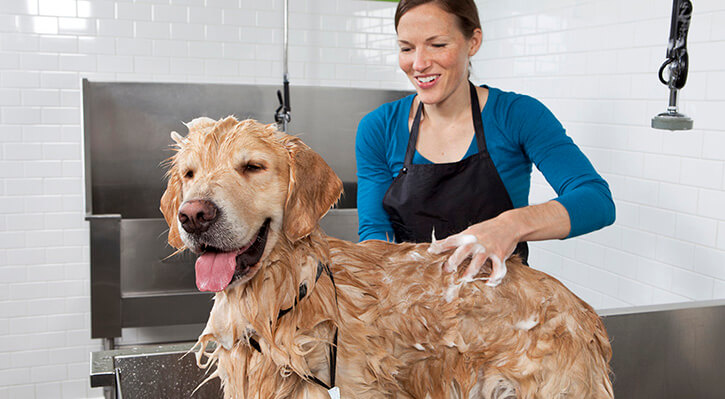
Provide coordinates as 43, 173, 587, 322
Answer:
0, 0, 407, 398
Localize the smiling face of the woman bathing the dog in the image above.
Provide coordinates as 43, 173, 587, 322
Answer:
398, 3, 481, 104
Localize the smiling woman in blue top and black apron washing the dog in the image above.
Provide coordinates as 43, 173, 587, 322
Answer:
356, 0, 615, 276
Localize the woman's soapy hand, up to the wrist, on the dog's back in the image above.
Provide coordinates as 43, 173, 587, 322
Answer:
428, 214, 519, 286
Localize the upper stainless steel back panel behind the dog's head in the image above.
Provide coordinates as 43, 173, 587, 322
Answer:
83, 81, 408, 218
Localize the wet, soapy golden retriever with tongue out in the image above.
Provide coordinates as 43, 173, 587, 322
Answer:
161, 117, 613, 399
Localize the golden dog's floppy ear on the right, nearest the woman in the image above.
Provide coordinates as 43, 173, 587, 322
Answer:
284, 136, 342, 242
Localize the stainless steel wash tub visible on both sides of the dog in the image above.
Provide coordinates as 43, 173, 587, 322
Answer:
91, 300, 725, 399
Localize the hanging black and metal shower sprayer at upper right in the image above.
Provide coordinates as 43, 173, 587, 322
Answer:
652, 0, 693, 130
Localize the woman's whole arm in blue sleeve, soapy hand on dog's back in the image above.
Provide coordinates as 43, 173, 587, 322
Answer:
430, 96, 615, 285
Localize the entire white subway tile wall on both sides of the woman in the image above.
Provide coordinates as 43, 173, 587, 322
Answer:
0, 0, 725, 399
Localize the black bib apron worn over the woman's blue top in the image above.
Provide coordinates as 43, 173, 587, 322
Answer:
383, 82, 529, 262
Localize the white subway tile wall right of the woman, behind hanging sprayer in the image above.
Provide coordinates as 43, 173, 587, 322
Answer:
473, 0, 725, 308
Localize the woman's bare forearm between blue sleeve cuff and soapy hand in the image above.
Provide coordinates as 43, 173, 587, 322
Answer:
497, 200, 571, 242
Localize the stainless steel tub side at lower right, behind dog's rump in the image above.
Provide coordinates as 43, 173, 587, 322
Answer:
602, 300, 725, 399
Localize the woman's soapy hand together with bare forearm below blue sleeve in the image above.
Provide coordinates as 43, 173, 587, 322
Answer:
428, 201, 571, 286
